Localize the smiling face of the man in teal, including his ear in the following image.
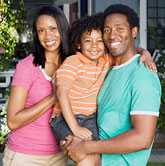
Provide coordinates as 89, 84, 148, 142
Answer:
103, 13, 137, 56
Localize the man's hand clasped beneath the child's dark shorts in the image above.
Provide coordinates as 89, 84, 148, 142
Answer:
67, 141, 87, 163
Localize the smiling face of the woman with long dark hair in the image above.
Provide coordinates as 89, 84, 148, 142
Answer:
36, 15, 61, 52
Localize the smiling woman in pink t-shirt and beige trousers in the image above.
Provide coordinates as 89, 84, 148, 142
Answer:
3, 6, 69, 166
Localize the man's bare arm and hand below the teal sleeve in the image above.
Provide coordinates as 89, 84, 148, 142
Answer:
68, 115, 157, 161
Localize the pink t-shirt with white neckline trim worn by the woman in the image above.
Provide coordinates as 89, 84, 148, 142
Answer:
7, 55, 59, 155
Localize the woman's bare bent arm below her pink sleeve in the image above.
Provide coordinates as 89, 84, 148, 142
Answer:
7, 86, 55, 130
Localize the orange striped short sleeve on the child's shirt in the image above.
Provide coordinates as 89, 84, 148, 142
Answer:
56, 57, 78, 87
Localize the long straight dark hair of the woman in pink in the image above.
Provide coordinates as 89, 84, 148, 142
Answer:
33, 5, 69, 68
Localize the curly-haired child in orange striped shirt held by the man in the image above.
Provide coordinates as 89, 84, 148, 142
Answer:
51, 14, 156, 166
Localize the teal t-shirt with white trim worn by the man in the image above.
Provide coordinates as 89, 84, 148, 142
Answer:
97, 54, 161, 166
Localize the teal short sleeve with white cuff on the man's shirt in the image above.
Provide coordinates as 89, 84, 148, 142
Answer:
130, 68, 161, 116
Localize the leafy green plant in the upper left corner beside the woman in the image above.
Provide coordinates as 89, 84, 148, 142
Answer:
0, 0, 24, 71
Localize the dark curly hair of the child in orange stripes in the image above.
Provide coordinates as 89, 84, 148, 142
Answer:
69, 13, 103, 54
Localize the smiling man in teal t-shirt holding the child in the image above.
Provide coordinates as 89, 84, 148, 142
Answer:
68, 5, 161, 166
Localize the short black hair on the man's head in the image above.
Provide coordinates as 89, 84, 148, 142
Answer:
104, 4, 139, 29
